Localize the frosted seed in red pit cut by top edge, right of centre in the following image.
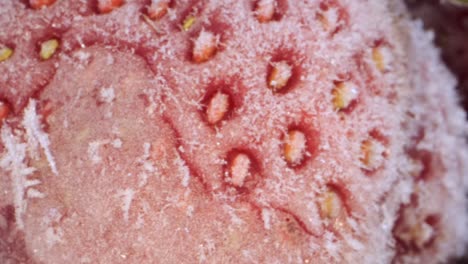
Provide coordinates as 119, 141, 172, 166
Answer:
253, 0, 288, 23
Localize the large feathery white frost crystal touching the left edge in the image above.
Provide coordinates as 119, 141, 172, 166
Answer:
0, 124, 40, 230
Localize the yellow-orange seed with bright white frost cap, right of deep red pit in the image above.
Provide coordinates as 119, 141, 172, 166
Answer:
332, 81, 359, 112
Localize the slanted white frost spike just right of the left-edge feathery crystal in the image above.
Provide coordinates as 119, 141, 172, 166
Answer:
22, 99, 58, 175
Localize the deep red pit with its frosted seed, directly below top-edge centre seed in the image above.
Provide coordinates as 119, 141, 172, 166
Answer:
266, 49, 302, 94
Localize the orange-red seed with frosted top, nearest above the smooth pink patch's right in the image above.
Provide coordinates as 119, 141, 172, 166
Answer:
192, 30, 219, 63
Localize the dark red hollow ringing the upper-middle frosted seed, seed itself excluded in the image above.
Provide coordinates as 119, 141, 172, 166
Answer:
265, 46, 304, 95
